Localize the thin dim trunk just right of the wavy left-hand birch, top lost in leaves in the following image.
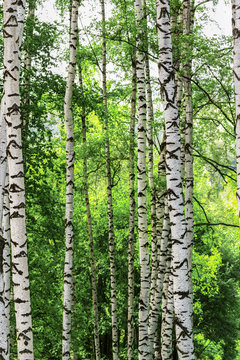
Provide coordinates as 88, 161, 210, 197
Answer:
79, 66, 101, 360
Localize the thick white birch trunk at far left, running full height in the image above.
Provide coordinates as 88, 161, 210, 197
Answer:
3, 0, 34, 360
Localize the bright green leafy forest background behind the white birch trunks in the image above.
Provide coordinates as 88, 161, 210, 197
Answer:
0, 0, 240, 360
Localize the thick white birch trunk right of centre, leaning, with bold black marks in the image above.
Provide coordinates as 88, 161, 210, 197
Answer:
156, 0, 194, 360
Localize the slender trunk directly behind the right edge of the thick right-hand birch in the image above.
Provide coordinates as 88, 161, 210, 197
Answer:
183, 0, 193, 312
